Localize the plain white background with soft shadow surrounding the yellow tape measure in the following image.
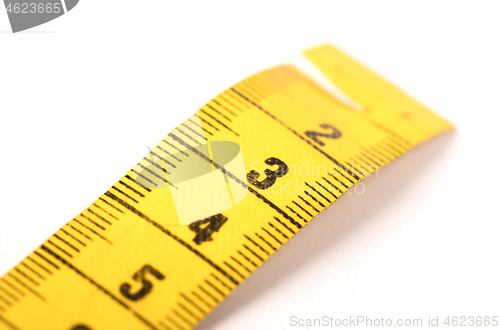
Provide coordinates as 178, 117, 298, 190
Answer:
0, 0, 500, 330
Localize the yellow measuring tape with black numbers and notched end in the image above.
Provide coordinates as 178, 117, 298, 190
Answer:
0, 46, 452, 330
